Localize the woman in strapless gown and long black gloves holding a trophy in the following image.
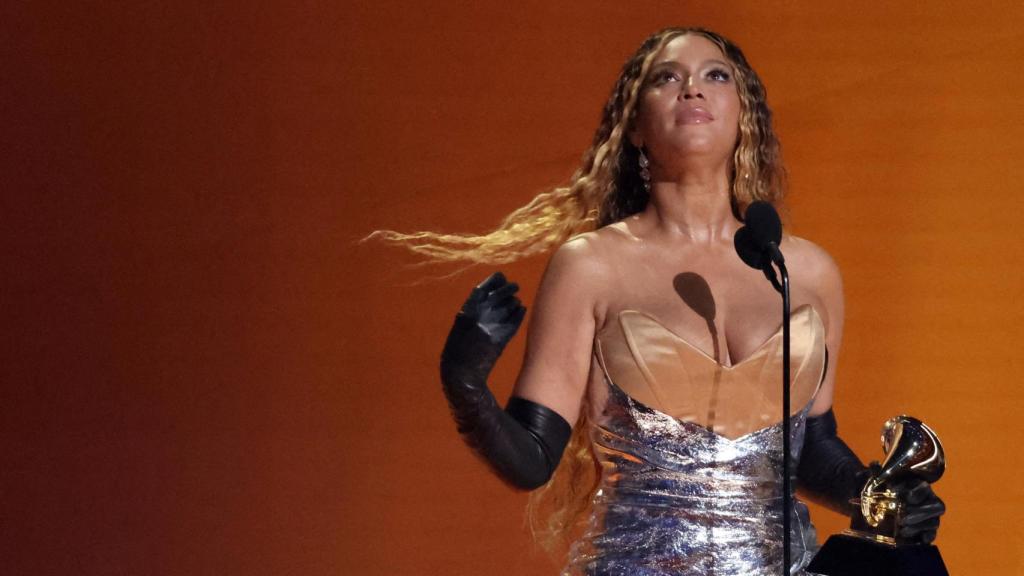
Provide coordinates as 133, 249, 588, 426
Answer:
376, 29, 942, 575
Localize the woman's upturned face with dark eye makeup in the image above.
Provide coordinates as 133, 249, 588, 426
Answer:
630, 34, 740, 170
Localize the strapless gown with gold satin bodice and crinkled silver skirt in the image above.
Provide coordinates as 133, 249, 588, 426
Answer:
563, 306, 825, 576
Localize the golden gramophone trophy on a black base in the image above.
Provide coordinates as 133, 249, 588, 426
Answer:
807, 415, 948, 576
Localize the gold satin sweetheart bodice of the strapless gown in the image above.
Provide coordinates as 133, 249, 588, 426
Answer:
594, 304, 825, 440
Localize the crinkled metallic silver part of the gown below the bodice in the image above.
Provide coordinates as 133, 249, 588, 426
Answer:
564, 379, 816, 576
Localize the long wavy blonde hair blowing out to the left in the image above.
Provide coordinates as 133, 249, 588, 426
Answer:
368, 28, 784, 553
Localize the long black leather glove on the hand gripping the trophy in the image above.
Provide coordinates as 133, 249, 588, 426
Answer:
797, 408, 946, 543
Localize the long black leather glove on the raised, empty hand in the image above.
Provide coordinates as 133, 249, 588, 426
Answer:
440, 272, 572, 490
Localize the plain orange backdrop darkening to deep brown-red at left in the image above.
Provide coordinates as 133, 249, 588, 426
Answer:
0, 0, 1024, 576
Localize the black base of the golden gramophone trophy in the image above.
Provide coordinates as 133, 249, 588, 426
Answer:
807, 534, 949, 576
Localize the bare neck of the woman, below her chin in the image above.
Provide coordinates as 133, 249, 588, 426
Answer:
644, 163, 739, 244
